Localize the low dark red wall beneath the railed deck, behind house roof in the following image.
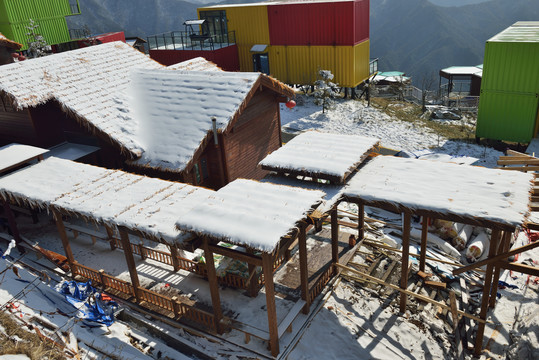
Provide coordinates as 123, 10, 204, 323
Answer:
150, 45, 240, 71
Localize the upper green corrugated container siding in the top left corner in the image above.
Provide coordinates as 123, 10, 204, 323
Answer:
4, 0, 71, 23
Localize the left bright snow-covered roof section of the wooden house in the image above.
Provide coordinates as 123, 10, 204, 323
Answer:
0, 41, 163, 155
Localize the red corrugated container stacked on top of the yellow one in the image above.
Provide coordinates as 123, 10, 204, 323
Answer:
268, 0, 369, 46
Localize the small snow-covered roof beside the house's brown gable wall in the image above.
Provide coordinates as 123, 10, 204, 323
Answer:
260, 131, 380, 183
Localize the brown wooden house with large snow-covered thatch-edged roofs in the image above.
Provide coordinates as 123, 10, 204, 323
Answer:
0, 42, 293, 188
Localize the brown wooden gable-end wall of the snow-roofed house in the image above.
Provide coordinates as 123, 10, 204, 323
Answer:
224, 90, 281, 182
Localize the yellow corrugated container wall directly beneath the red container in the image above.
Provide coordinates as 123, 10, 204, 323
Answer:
268, 40, 369, 87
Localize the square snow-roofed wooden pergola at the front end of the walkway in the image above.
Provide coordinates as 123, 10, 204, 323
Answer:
177, 180, 324, 356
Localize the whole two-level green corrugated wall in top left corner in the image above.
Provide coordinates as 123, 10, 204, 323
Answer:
0, 0, 79, 50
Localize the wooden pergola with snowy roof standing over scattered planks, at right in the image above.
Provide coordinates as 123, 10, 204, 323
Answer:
338, 156, 539, 355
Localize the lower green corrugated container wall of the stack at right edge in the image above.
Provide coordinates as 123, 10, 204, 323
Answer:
476, 91, 539, 143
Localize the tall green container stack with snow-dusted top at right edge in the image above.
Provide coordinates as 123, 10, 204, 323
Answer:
476, 21, 539, 143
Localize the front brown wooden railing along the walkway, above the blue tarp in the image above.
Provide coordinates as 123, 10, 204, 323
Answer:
73, 263, 216, 331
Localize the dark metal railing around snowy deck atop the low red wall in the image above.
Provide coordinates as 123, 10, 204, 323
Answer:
148, 31, 236, 51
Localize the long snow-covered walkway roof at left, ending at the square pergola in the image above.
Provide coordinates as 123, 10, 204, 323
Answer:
0, 157, 214, 243
